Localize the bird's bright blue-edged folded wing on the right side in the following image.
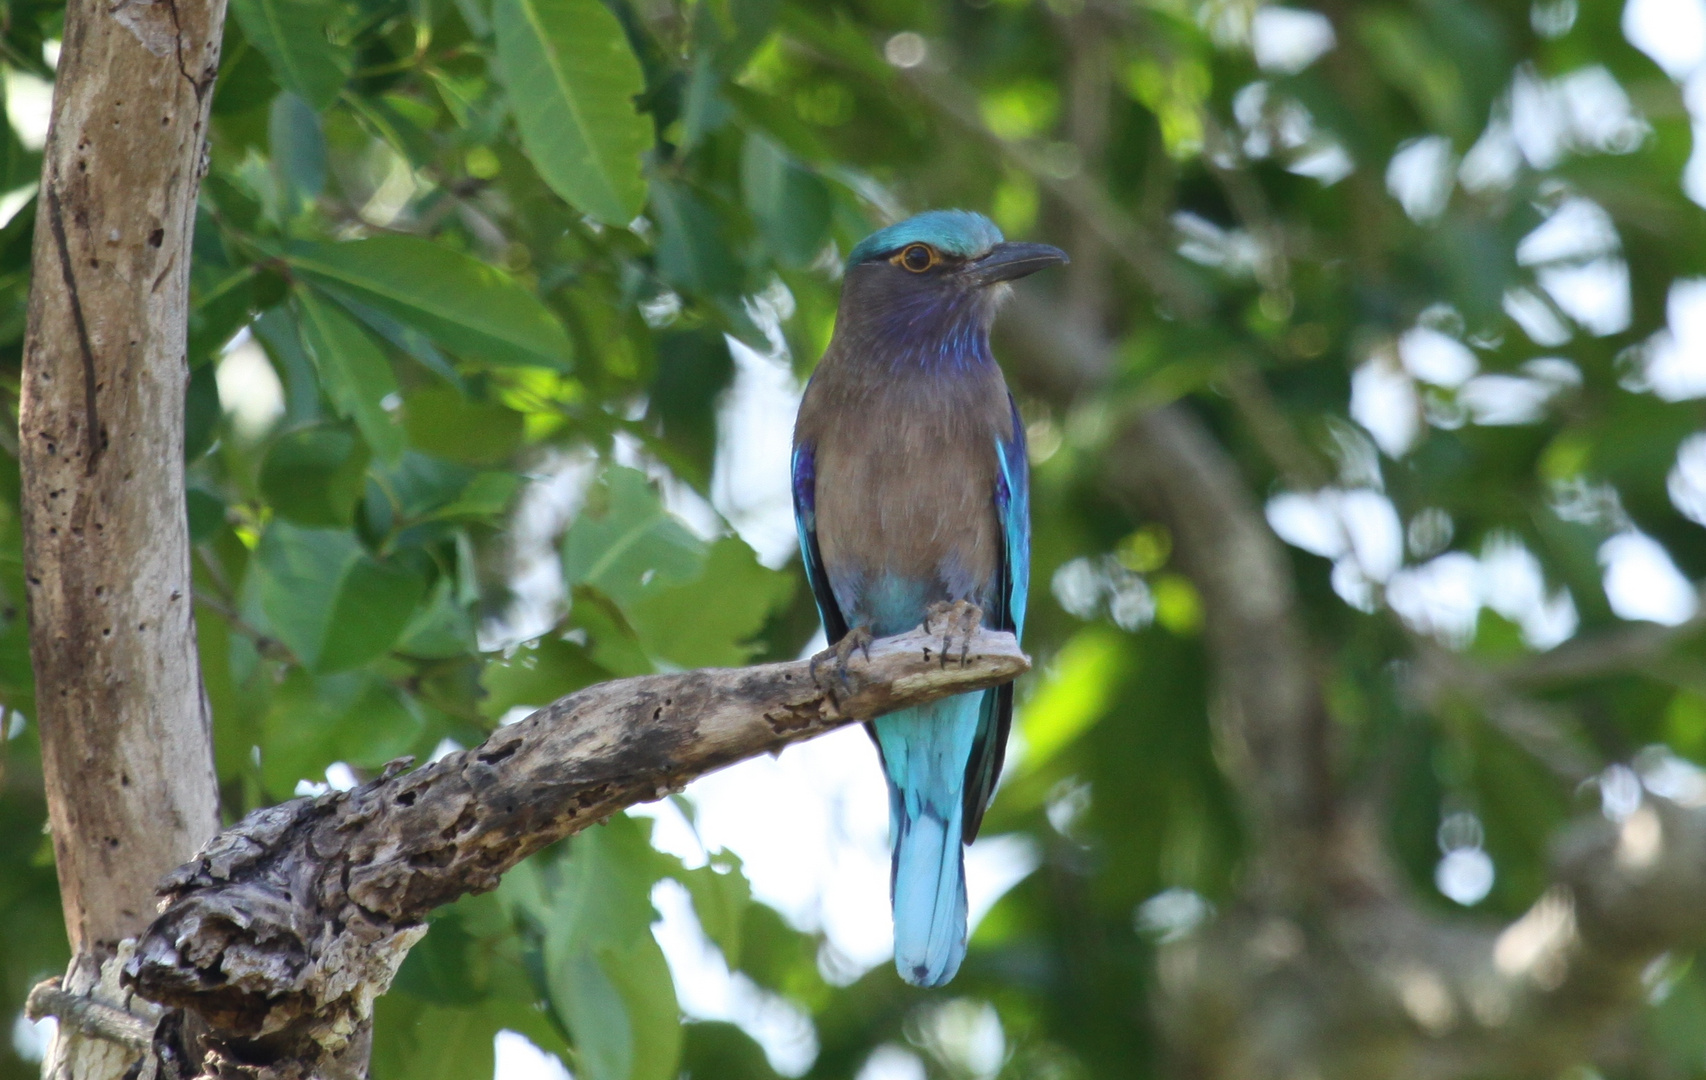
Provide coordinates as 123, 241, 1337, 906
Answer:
964, 398, 1030, 843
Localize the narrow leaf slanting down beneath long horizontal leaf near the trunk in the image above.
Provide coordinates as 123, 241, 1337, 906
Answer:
297, 288, 403, 462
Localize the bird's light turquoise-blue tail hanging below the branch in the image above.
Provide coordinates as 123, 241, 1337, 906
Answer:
875, 694, 981, 986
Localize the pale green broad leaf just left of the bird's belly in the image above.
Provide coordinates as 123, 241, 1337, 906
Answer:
563, 466, 705, 604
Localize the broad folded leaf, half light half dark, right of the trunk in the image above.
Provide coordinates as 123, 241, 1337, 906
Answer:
254, 519, 425, 672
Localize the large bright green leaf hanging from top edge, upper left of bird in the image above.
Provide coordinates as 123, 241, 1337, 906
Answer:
491, 0, 652, 225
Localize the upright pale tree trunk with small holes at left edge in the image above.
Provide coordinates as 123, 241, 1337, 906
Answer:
19, 0, 225, 1077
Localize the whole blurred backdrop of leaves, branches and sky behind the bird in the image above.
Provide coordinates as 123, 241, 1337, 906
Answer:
10, 0, 1706, 1080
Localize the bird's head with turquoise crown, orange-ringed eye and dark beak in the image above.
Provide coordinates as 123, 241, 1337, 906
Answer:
838, 210, 1068, 361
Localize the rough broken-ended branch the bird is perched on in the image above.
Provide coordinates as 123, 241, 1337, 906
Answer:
125, 614, 1029, 1080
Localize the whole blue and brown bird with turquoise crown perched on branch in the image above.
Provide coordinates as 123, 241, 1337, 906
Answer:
792, 210, 1068, 986
